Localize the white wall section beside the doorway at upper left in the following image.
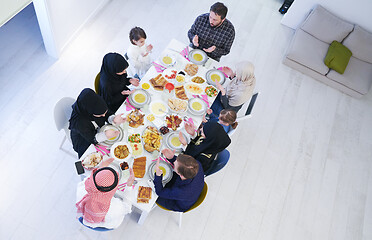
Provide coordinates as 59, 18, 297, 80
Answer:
34, 0, 108, 58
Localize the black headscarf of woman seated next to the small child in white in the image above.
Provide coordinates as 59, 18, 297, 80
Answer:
100, 53, 129, 82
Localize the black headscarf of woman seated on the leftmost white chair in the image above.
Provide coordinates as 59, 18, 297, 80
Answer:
70, 88, 109, 129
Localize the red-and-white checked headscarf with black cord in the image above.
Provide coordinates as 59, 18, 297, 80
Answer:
76, 167, 118, 223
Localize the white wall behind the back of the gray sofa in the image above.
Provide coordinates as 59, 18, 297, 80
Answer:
281, 0, 372, 32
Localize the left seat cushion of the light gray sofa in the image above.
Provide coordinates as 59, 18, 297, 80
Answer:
287, 29, 329, 75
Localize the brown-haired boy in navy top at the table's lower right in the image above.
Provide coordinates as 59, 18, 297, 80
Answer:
154, 152, 204, 212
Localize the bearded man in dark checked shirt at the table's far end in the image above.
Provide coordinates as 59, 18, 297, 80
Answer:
188, 2, 235, 61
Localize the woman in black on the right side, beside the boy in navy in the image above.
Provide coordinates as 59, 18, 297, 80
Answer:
180, 122, 231, 172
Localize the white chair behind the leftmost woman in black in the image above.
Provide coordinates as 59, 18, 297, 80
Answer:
54, 97, 76, 157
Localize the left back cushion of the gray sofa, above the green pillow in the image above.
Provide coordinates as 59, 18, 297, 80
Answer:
301, 5, 354, 44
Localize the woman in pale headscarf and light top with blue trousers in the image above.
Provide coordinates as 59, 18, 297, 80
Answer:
211, 61, 256, 116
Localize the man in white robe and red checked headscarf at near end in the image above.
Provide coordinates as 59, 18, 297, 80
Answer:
76, 158, 134, 229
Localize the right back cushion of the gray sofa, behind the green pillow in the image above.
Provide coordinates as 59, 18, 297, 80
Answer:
343, 25, 372, 63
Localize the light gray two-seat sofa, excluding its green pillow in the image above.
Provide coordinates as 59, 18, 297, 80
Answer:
283, 5, 372, 97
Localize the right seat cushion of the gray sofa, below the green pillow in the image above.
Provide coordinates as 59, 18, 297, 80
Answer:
327, 57, 372, 95
